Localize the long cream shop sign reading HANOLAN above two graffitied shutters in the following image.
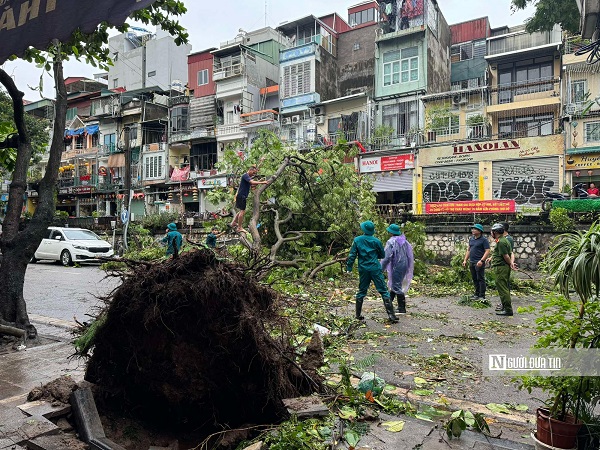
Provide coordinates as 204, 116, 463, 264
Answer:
419, 134, 564, 167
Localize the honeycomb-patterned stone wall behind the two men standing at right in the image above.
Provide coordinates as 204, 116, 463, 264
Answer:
425, 230, 556, 270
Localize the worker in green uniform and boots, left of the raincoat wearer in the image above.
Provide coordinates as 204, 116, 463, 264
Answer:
346, 220, 398, 323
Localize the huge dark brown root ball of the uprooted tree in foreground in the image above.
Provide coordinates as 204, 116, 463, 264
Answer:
86, 250, 322, 432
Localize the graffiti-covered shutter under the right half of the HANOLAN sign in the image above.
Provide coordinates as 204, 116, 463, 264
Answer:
494, 162, 557, 205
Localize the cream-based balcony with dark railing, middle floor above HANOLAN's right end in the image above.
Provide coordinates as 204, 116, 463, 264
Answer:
487, 78, 561, 114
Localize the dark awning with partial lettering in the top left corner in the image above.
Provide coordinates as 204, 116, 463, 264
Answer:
0, 0, 155, 64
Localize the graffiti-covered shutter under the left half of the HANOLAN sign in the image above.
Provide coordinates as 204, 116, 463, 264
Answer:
423, 170, 477, 203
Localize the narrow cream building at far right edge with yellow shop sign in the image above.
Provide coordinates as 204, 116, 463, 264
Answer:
562, 37, 600, 188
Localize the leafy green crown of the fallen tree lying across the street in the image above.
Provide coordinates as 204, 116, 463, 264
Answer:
208, 132, 376, 277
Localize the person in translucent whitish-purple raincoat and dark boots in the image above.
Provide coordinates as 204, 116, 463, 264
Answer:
381, 223, 415, 314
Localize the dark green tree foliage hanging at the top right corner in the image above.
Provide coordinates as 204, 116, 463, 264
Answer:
511, 0, 580, 34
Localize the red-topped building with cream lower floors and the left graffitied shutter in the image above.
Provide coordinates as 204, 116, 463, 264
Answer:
415, 17, 491, 212
